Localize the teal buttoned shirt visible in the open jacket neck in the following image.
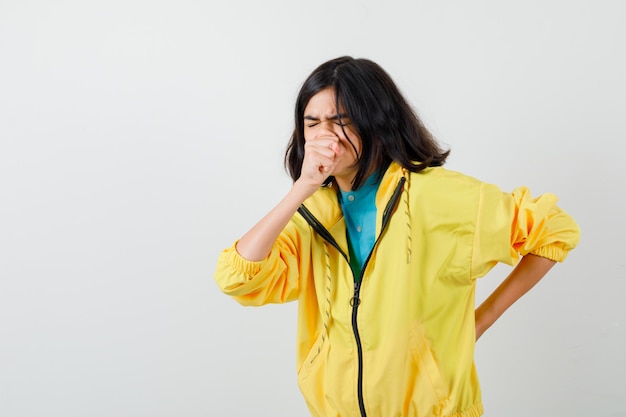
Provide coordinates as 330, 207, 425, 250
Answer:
340, 172, 381, 279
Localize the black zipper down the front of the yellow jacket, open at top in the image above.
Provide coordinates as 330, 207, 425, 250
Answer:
298, 177, 406, 417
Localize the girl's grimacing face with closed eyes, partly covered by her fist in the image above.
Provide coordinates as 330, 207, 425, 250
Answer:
304, 88, 361, 188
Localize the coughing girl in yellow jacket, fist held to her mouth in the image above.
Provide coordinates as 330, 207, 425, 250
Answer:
215, 57, 579, 417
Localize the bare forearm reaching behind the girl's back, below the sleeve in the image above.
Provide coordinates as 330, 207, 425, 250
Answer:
475, 254, 556, 340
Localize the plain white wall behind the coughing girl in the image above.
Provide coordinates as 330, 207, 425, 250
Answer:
0, 0, 626, 417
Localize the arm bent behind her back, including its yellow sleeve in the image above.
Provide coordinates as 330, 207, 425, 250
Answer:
473, 185, 580, 339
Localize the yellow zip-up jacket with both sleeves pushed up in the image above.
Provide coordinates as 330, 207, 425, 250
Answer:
215, 163, 579, 417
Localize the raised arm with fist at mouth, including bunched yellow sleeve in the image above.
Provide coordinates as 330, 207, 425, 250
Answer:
214, 137, 343, 306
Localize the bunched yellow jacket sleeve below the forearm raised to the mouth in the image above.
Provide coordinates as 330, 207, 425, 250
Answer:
214, 223, 299, 306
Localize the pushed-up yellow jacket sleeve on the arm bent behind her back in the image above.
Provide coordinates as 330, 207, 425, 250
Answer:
472, 184, 580, 278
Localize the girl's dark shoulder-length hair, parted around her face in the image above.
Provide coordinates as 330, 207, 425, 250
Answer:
285, 56, 450, 190
